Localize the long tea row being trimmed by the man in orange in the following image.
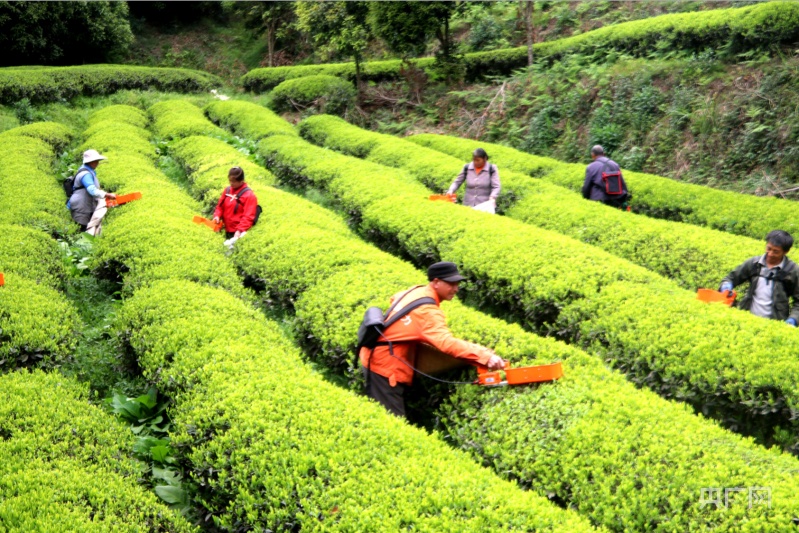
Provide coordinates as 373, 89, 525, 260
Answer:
171, 130, 799, 531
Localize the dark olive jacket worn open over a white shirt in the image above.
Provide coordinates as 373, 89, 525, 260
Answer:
721, 255, 799, 322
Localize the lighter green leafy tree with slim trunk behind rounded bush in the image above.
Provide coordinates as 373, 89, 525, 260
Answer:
297, 0, 371, 90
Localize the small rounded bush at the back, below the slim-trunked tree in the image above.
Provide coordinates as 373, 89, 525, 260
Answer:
272, 74, 355, 115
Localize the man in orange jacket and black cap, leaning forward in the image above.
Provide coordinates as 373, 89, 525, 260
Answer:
359, 263, 505, 417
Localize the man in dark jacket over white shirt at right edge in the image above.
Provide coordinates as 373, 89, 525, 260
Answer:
719, 229, 799, 327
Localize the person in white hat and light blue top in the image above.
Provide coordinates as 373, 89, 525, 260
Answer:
67, 150, 117, 237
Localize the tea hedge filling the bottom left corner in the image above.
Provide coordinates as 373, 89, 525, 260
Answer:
0, 371, 195, 532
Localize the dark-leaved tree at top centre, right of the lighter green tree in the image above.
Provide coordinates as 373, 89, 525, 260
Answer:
369, 2, 464, 58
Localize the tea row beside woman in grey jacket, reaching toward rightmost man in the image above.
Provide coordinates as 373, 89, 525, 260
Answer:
299, 115, 763, 290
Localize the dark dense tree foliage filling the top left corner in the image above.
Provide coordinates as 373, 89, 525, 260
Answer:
0, 1, 133, 65
